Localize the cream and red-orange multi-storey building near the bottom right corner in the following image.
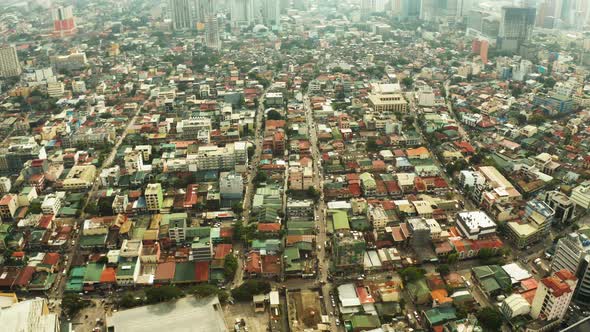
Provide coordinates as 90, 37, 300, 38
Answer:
531, 270, 578, 321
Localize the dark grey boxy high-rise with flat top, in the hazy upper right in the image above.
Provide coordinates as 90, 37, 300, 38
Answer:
498, 7, 536, 52
